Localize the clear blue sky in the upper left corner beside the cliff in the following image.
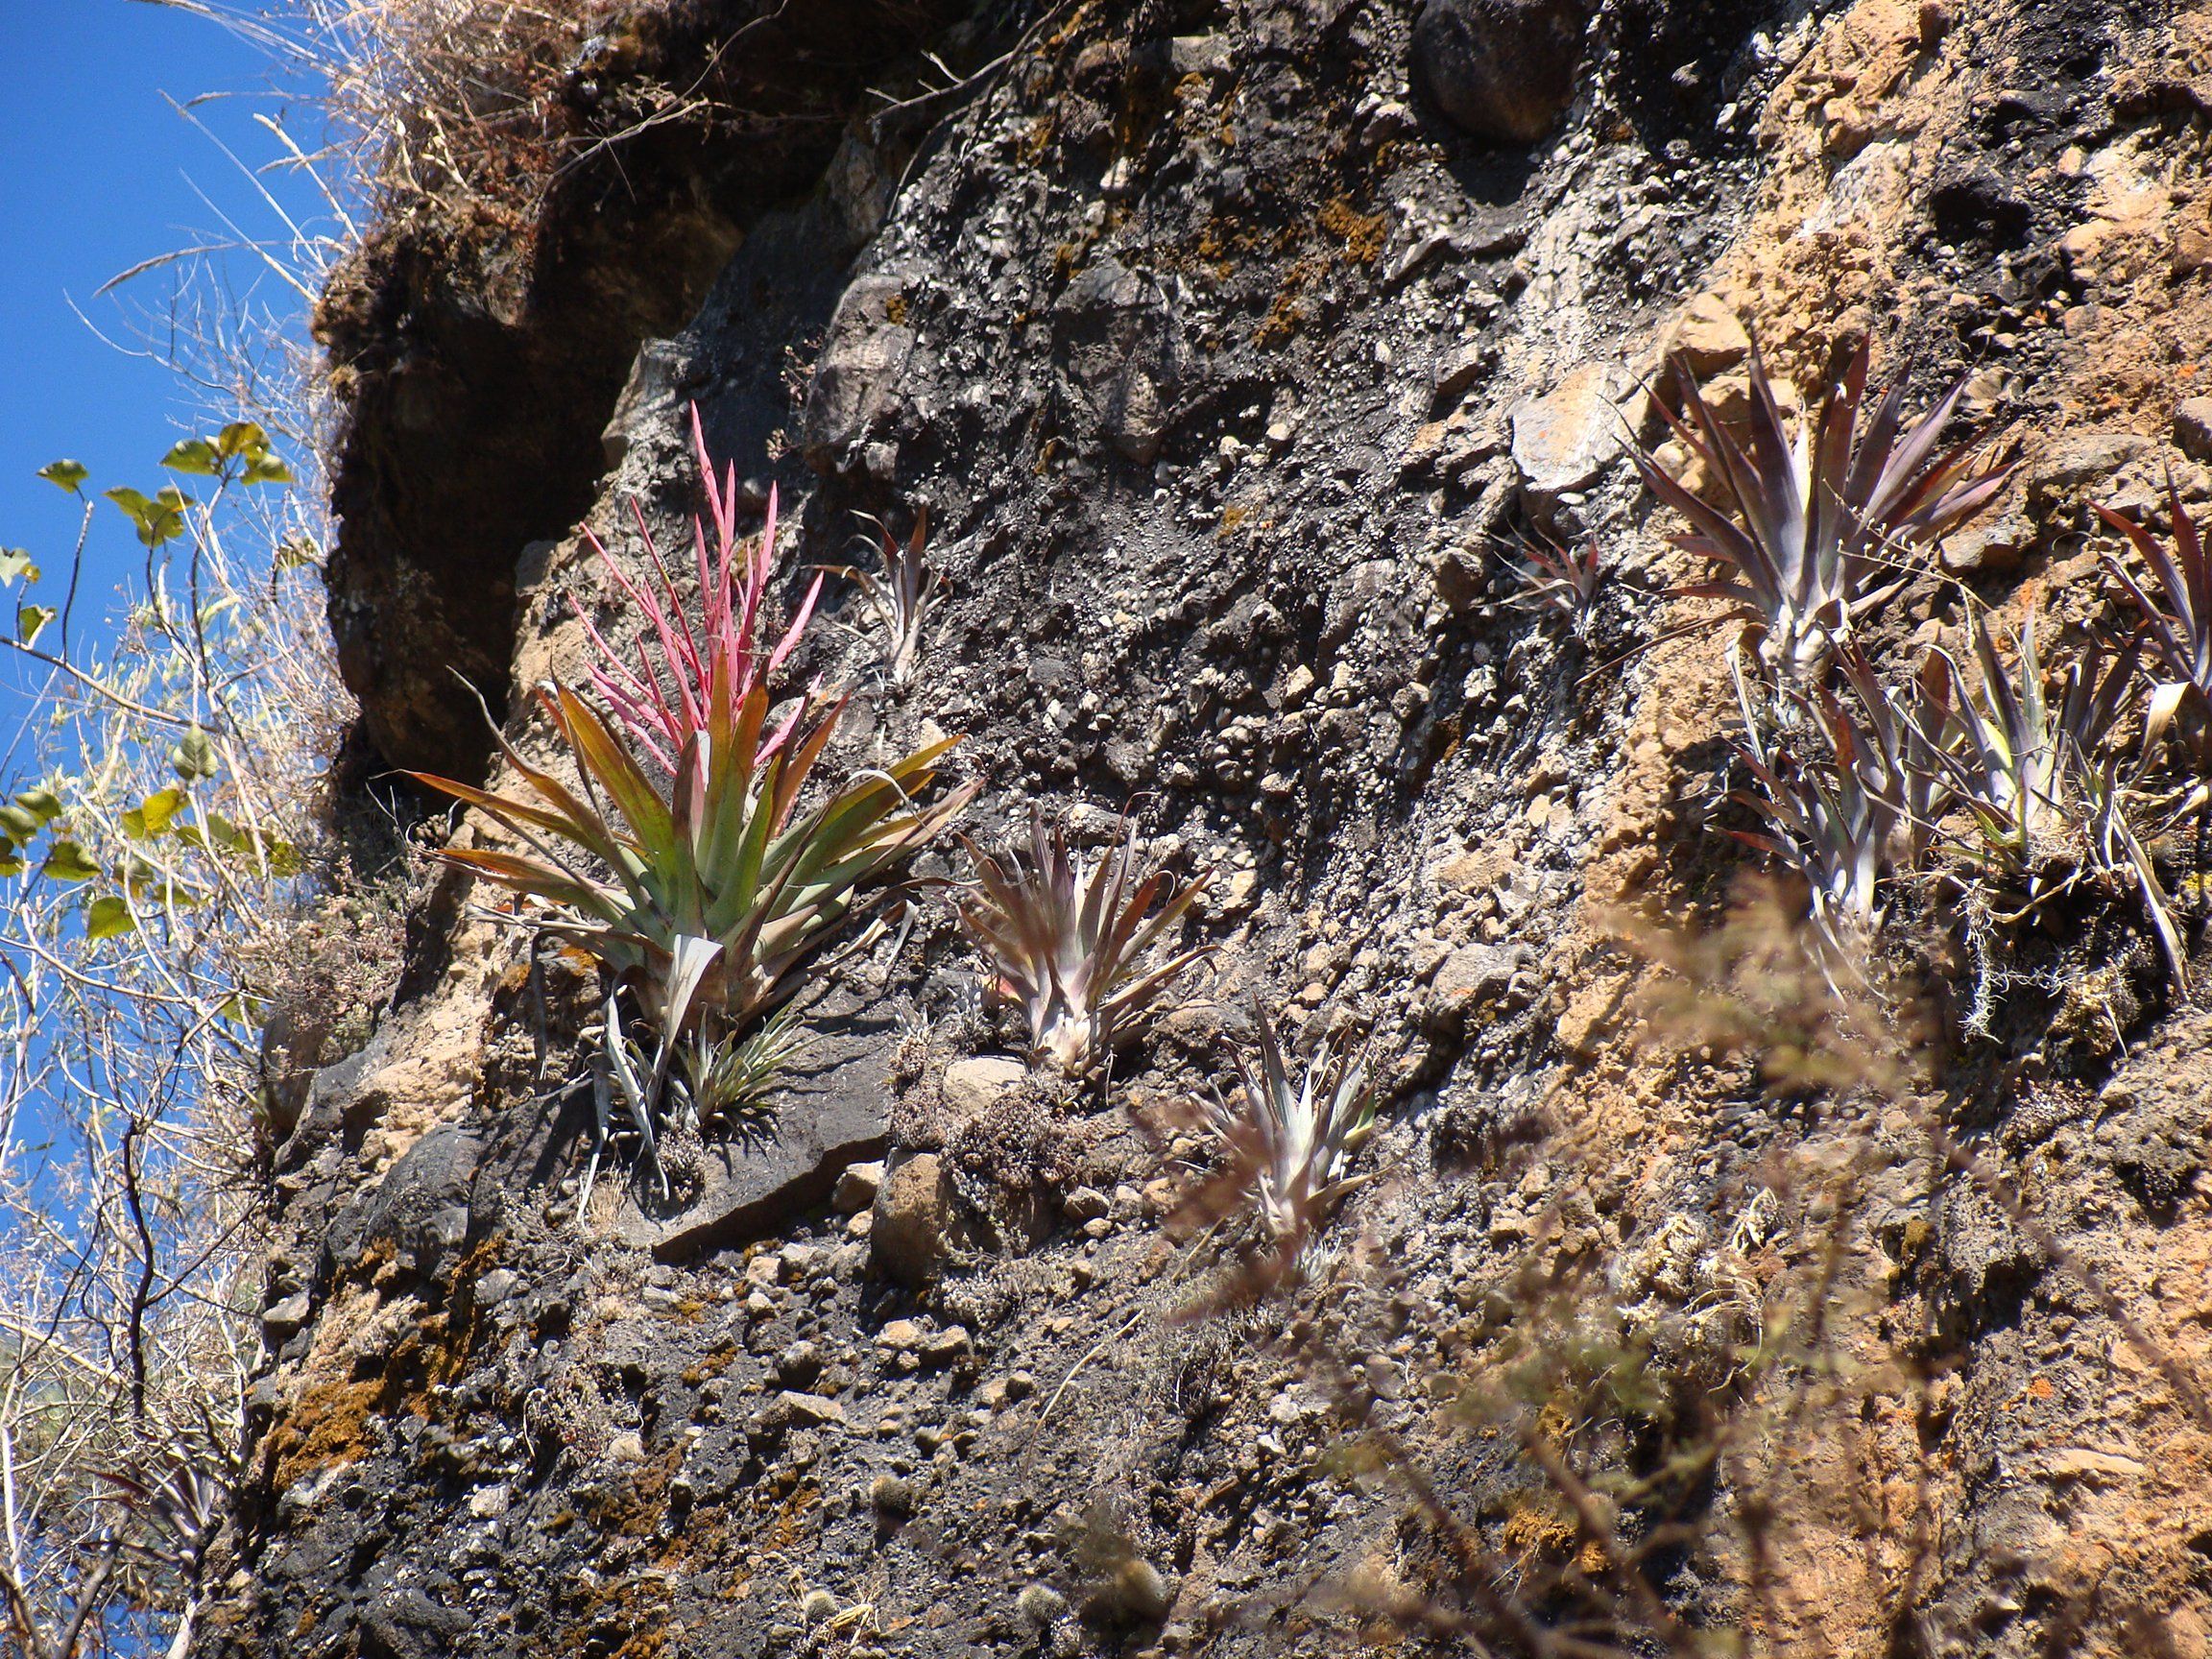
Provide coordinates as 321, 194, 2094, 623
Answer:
0, 0, 331, 725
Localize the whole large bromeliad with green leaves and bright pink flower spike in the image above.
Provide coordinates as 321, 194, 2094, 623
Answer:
414, 407, 974, 1208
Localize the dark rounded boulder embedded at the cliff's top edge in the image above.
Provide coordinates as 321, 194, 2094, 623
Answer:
1411, 0, 1588, 144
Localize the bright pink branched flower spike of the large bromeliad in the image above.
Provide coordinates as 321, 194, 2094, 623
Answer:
570, 405, 823, 783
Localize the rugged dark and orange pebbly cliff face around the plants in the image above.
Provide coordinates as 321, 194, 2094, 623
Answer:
215, 0, 2212, 1659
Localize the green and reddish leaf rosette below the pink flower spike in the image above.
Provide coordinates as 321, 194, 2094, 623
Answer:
414, 663, 975, 1046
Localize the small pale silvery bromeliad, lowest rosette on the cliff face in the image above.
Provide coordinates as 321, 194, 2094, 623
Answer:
1208, 998, 1376, 1267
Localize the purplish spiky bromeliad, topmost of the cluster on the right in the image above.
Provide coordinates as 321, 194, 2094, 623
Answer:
1635, 331, 2007, 685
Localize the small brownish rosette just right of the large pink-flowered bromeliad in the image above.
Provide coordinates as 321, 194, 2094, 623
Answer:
960, 812, 1210, 1077
